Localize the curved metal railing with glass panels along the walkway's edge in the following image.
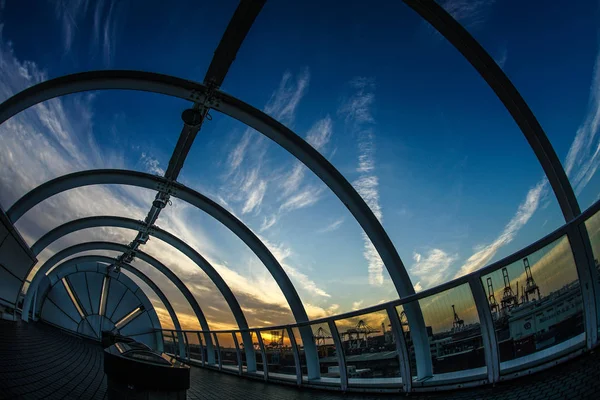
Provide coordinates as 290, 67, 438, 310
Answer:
156, 198, 600, 392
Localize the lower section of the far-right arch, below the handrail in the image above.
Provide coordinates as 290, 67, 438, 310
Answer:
567, 222, 600, 349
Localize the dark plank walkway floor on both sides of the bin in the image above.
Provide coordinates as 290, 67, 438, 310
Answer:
0, 320, 600, 400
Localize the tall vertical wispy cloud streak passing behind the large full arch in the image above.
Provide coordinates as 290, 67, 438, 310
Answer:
339, 77, 384, 286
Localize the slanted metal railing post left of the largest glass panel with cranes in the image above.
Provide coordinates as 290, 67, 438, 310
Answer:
469, 276, 500, 383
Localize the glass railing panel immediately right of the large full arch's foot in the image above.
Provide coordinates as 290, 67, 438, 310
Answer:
401, 284, 487, 379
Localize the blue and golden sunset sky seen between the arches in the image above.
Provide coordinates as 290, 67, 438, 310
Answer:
0, 0, 600, 329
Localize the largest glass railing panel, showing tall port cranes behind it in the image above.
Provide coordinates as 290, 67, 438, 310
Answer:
481, 236, 584, 370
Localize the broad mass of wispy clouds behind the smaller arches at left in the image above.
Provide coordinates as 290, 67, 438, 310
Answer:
0, 36, 314, 329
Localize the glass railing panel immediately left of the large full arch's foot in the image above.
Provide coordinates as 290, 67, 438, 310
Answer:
335, 310, 400, 385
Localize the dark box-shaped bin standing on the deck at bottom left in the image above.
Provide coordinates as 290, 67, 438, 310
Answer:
104, 341, 190, 400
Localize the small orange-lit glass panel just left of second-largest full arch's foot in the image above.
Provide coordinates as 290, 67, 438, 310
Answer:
260, 329, 296, 375
